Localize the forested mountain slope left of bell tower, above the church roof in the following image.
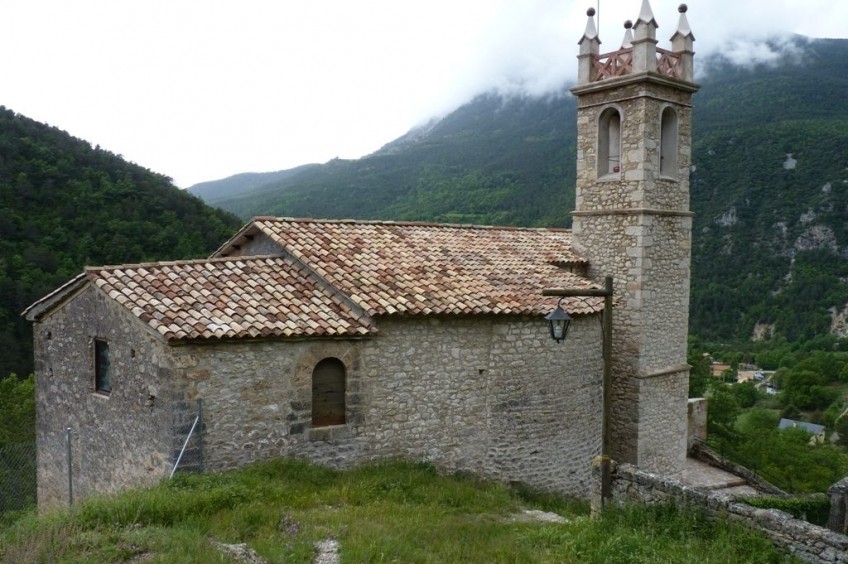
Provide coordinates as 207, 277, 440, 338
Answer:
194, 95, 576, 225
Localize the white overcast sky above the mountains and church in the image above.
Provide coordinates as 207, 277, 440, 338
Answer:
0, 0, 848, 187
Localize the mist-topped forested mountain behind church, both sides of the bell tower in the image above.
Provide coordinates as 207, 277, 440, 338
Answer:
198, 38, 848, 340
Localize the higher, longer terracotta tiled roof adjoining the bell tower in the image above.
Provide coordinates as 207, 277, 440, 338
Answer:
216, 217, 602, 315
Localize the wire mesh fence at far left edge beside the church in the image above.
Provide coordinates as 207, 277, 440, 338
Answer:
0, 441, 37, 517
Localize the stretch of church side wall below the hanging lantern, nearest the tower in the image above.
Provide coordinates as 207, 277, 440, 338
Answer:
476, 316, 603, 497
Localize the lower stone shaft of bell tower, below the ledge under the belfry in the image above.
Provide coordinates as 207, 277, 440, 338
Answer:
574, 207, 691, 474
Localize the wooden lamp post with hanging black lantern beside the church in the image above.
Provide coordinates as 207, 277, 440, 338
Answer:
542, 276, 612, 510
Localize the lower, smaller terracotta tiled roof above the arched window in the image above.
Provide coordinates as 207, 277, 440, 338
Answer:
86, 257, 374, 340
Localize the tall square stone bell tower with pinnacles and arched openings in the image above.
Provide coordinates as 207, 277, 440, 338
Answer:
571, 0, 698, 475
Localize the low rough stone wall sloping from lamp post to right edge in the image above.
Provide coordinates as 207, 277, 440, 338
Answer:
596, 464, 848, 563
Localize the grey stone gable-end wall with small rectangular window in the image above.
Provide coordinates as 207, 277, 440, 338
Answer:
34, 286, 174, 508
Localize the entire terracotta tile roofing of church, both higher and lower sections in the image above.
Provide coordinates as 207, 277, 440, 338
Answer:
24, 217, 603, 340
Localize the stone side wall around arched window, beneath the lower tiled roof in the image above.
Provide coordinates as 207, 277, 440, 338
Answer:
170, 340, 367, 471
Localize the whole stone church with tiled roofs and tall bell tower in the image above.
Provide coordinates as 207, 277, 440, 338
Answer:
24, 0, 697, 507
